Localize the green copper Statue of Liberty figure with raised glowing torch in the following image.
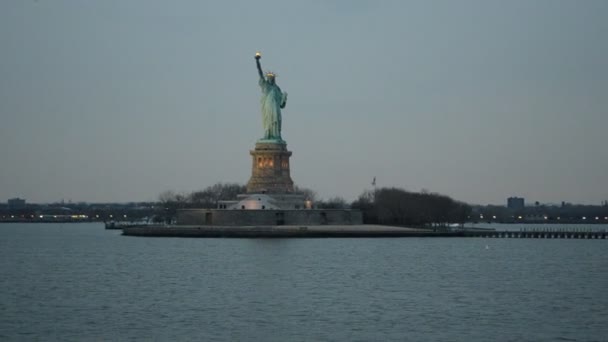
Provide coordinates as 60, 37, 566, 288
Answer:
255, 52, 287, 141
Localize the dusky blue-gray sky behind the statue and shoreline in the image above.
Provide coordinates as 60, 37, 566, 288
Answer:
0, 0, 608, 204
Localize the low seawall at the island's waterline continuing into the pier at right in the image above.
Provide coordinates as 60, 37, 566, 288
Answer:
122, 225, 608, 239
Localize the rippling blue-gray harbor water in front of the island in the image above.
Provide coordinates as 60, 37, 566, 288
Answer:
0, 224, 608, 341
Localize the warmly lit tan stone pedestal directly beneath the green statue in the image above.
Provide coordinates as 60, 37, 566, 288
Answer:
247, 140, 293, 194
